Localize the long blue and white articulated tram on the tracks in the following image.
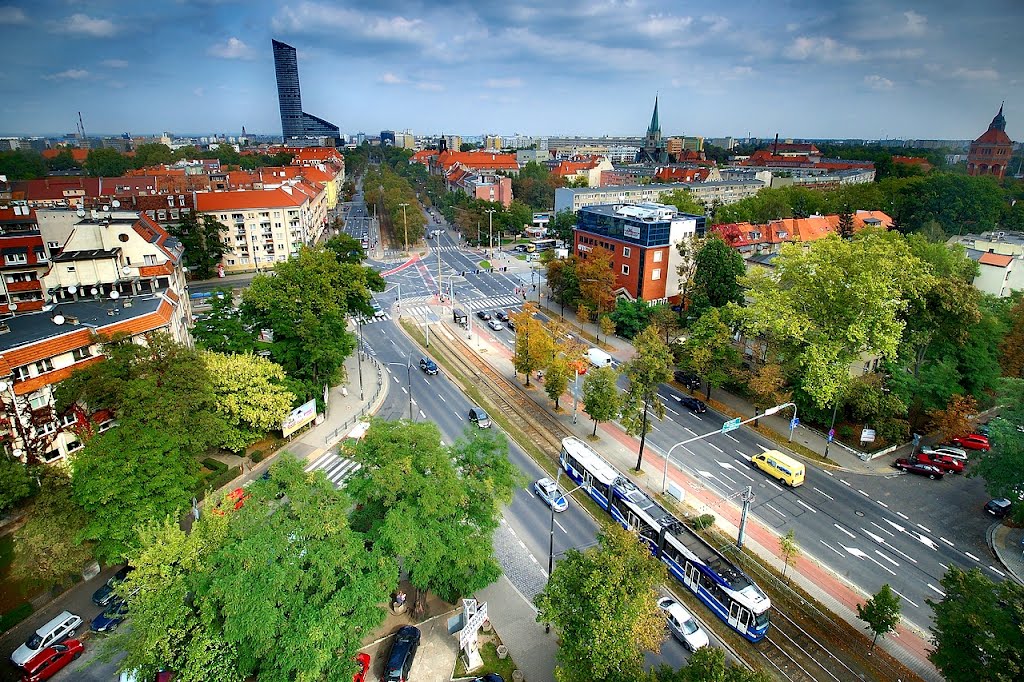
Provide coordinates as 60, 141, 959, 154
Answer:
559, 437, 771, 642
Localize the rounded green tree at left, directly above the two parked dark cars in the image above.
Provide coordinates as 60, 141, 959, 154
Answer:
72, 424, 199, 563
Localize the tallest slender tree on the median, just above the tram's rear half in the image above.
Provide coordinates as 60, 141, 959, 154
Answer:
622, 327, 673, 471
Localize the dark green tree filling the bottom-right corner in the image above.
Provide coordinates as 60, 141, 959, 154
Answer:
926, 566, 1024, 682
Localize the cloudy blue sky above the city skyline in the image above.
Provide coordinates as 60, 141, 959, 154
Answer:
0, 0, 1024, 140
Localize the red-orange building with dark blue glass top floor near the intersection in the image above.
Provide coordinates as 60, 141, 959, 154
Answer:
573, 203, 706, 303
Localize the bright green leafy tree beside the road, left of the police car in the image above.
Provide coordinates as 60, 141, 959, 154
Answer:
347, 421, 519, 602
